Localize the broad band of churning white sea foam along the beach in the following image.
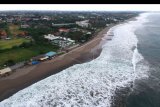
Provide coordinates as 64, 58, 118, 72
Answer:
0, 14, 148, 107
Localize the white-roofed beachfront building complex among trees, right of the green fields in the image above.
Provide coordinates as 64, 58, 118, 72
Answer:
44, 34, 75, 48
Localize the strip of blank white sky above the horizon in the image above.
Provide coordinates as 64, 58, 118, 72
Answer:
0, 4, 160, 11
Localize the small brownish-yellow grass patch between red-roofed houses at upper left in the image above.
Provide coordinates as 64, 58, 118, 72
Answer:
8, 24, 24, 36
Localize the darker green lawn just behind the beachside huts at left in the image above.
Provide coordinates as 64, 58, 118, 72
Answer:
0, 45, 57, 69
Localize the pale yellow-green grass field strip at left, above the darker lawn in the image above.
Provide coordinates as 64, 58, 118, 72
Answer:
0, 38, 30, 50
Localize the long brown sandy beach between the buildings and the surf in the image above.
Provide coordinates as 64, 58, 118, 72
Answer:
0, 24, 115, 101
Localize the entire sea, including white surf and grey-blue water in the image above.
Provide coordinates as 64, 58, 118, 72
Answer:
0, 13, 160, 107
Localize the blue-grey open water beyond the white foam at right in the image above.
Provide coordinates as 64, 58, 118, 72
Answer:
122, 13, 160, 107
